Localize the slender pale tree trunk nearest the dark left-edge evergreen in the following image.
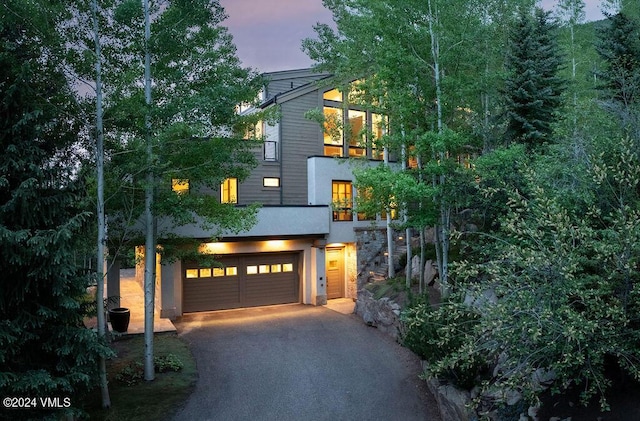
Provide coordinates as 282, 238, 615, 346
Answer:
91, 0, 111, 408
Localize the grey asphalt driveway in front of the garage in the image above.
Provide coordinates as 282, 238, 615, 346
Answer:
175, 305, 440, 421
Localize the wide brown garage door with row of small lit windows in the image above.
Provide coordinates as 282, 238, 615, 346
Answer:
182, 253, 300, 313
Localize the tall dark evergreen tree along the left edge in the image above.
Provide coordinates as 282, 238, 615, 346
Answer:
0, 0, 109, 419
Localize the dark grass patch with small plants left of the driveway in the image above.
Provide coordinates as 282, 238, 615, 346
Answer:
85, 333, 198, 421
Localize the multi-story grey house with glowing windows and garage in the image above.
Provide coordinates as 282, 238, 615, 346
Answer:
117, 69, 398, 318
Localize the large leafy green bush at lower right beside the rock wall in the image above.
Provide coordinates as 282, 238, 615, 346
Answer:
404, 139, 640, 407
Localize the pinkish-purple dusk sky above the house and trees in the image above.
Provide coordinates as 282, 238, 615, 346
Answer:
220, 0, 603, 73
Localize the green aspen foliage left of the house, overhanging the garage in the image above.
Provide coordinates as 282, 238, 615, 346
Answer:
67, 0, 268, 258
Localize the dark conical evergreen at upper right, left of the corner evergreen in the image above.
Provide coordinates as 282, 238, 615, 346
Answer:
504, 9, 565, 150
